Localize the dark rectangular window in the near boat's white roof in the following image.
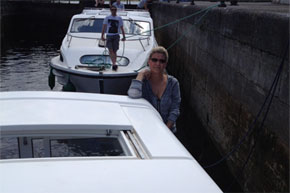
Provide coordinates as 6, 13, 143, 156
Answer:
0, 130, 144, 159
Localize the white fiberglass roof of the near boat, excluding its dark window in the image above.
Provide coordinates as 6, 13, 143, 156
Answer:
0, 92, 221, 193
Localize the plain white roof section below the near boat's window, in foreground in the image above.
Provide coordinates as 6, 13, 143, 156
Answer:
0, 158, 221, 193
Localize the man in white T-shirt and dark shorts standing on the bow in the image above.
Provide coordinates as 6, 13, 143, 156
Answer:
101, 6, 126, 71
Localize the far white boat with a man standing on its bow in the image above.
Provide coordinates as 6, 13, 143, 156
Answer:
50, 8, 157, 94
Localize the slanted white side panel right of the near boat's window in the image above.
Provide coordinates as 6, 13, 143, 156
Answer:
123, 107, 193, 159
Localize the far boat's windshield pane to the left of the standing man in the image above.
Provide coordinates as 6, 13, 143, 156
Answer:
70, 18, 103, 33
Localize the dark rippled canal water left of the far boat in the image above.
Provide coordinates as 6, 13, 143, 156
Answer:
0, 18, 64, 91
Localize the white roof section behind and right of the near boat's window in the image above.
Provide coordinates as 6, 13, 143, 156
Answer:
0, 92, 192, 159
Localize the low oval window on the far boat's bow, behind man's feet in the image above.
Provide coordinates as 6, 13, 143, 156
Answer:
80, 55, 129, 66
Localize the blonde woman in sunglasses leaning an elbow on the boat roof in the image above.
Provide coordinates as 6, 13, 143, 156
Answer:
128, 47, 181, 133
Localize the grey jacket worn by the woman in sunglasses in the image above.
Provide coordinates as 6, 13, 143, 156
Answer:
128, 75, 181, 133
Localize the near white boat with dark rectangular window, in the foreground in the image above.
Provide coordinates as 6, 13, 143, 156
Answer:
0, 92, 222, 193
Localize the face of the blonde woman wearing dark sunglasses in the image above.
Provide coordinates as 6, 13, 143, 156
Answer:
148, 53, 167, 73
